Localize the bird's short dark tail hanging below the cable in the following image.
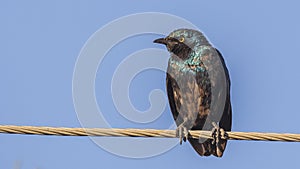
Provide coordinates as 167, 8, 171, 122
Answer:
189, 138, 227, 157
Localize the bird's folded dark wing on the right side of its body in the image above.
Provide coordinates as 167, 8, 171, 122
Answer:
196, 47, 231, 131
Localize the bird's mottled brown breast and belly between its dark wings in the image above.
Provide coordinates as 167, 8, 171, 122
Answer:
167, 58, 210, 128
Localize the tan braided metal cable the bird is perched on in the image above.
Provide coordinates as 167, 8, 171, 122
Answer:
0, 125, 300, 142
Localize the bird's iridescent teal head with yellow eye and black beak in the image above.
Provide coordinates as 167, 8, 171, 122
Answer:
154, 29, 209, 60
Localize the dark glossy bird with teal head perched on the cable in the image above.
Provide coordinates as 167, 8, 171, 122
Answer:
153, 28, 232, 157
